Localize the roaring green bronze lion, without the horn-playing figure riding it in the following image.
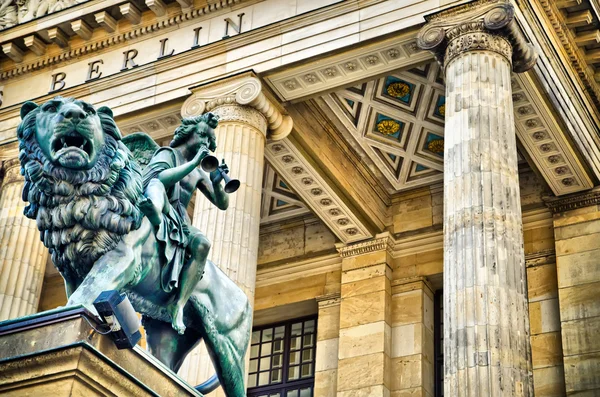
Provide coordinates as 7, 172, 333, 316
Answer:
17, 97, 252, 397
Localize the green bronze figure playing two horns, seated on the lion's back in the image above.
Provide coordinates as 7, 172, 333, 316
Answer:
139, 113, 229, 334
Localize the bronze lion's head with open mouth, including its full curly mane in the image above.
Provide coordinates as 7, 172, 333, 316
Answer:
17, 97, 143, 278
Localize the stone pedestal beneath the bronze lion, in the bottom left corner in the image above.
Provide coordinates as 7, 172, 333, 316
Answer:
0, 307, 202, 397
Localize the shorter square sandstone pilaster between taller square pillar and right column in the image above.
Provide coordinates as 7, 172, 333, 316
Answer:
390, 277, 435, 397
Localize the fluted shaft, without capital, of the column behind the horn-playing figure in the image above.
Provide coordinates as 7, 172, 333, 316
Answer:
180, 104, 267, 395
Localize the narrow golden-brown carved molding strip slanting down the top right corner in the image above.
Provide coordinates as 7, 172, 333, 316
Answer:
539, 0, 600, 112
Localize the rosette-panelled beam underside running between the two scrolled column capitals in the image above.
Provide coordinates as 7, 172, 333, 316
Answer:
265, 32, 431, 101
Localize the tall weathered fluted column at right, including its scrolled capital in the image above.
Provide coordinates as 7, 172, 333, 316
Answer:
418, 1, 536, 396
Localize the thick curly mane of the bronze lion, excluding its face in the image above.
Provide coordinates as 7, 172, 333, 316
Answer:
17, 103, 143, 279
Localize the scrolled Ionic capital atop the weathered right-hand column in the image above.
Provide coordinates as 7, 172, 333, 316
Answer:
417, 0, 537, 73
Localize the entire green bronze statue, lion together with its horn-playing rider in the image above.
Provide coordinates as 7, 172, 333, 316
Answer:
17, 97, 251, 397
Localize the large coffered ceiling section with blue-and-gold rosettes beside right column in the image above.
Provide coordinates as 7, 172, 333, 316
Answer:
323, 62, 445, 191
